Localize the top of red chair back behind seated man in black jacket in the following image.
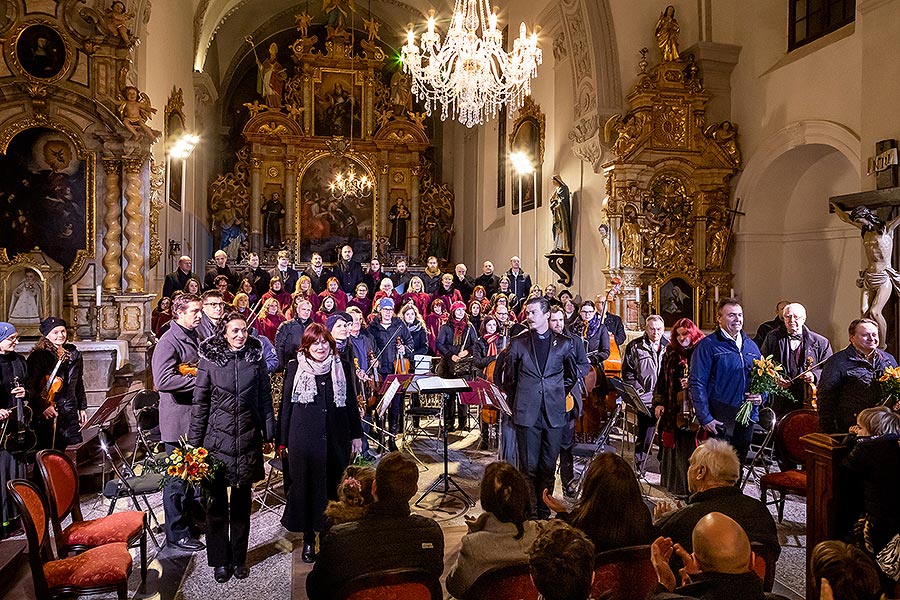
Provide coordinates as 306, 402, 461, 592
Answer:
333, 569, 444, 600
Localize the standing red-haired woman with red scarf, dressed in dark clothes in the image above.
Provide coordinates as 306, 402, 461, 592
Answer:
653, 319, 705, 496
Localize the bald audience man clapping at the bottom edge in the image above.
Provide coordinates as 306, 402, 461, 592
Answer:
650, 512, 766, 600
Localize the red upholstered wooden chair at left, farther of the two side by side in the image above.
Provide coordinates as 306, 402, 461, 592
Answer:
36, 450, 147, 580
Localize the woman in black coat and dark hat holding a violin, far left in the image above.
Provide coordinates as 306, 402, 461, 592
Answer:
28, 317, 87, 452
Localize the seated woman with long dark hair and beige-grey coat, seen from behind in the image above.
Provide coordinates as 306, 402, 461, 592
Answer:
447, 462, 539, 598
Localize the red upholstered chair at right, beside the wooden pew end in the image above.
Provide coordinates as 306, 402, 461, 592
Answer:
759, 408, 819, 523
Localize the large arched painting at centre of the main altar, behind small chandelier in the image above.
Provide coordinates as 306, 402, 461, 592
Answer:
297, 156, 376, 262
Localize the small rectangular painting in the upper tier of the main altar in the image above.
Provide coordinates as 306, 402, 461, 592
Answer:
313, 69, 362, 139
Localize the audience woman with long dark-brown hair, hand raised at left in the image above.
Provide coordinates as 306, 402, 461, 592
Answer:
544, 453, 656, 552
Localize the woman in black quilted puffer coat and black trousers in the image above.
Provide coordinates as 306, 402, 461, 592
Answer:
188, 312, 275, 583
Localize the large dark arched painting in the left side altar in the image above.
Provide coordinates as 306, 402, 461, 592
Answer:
0, 127, 94, 271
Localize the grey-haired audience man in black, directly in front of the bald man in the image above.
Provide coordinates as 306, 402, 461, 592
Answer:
654, 440, 781, 558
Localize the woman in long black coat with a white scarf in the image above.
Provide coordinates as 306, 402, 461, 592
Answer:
278, 323, 362, 562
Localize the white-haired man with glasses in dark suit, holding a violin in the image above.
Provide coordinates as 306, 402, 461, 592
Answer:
759, 302, 832, 418
